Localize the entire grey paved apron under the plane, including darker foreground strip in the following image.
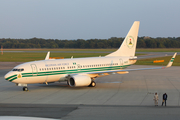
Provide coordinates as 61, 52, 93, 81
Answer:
0, 63, 180, 120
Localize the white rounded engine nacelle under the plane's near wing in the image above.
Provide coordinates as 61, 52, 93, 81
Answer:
68, 75, 91, 87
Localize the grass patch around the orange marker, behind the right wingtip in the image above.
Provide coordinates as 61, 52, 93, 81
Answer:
135, 55, 180, 66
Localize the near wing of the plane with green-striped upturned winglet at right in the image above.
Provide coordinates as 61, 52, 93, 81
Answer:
86, 53, 177, 78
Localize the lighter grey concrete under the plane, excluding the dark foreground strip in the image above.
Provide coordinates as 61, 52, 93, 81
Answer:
0, 65, 180, 106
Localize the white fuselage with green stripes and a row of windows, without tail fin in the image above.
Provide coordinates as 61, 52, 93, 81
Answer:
5, 57, 136, 84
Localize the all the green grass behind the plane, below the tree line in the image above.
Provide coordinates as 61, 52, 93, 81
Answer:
0, 49, 180, 66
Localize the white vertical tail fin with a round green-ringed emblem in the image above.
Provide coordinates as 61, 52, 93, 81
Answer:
106, 21, 140, 57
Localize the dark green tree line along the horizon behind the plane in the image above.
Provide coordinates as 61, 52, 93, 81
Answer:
0, 37, 180, 48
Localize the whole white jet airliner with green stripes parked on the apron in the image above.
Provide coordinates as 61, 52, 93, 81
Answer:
4, 21, 176, 91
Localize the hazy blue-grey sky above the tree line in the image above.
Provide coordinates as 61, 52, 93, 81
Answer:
0, 0, 180, 40
